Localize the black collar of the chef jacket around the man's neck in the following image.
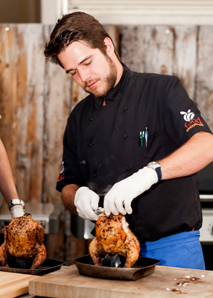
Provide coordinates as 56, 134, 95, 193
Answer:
93, 63, 130, 106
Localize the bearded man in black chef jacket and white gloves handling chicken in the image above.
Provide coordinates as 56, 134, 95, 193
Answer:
45, 12, 213, 269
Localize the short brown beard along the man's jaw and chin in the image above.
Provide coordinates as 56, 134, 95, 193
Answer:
83, 56, 117, 98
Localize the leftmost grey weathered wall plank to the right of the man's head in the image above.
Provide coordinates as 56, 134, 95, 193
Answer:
120, 26, 146, 72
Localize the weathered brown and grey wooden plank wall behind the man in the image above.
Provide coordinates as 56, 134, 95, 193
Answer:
0, 24, 213, 263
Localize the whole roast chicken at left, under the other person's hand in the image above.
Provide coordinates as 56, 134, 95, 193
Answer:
0, 213, 46, 269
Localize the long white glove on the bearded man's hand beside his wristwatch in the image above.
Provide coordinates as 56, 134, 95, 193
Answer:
104, 167, 158, 216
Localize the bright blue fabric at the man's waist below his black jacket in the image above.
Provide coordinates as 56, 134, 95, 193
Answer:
140, 231, 205, 270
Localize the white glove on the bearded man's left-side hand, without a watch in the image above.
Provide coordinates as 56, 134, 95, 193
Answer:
74, 186, 99, 220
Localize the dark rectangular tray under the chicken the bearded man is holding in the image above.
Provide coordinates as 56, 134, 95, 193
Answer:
73, 255, 161, 280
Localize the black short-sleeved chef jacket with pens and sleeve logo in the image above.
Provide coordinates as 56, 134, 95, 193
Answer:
56, 65, 211, 242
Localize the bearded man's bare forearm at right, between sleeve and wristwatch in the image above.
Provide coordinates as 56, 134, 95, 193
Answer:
159, 132, 213, 180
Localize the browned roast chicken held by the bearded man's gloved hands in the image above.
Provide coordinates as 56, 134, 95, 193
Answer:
89, 212, 140, 268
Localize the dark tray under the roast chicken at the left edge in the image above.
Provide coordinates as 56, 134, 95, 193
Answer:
0, 259, 65, 275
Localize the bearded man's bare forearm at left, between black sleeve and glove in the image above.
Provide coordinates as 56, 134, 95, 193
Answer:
61, 184, 79, 214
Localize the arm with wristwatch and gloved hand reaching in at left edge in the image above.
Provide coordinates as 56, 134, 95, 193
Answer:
0, 140, 24, 217
